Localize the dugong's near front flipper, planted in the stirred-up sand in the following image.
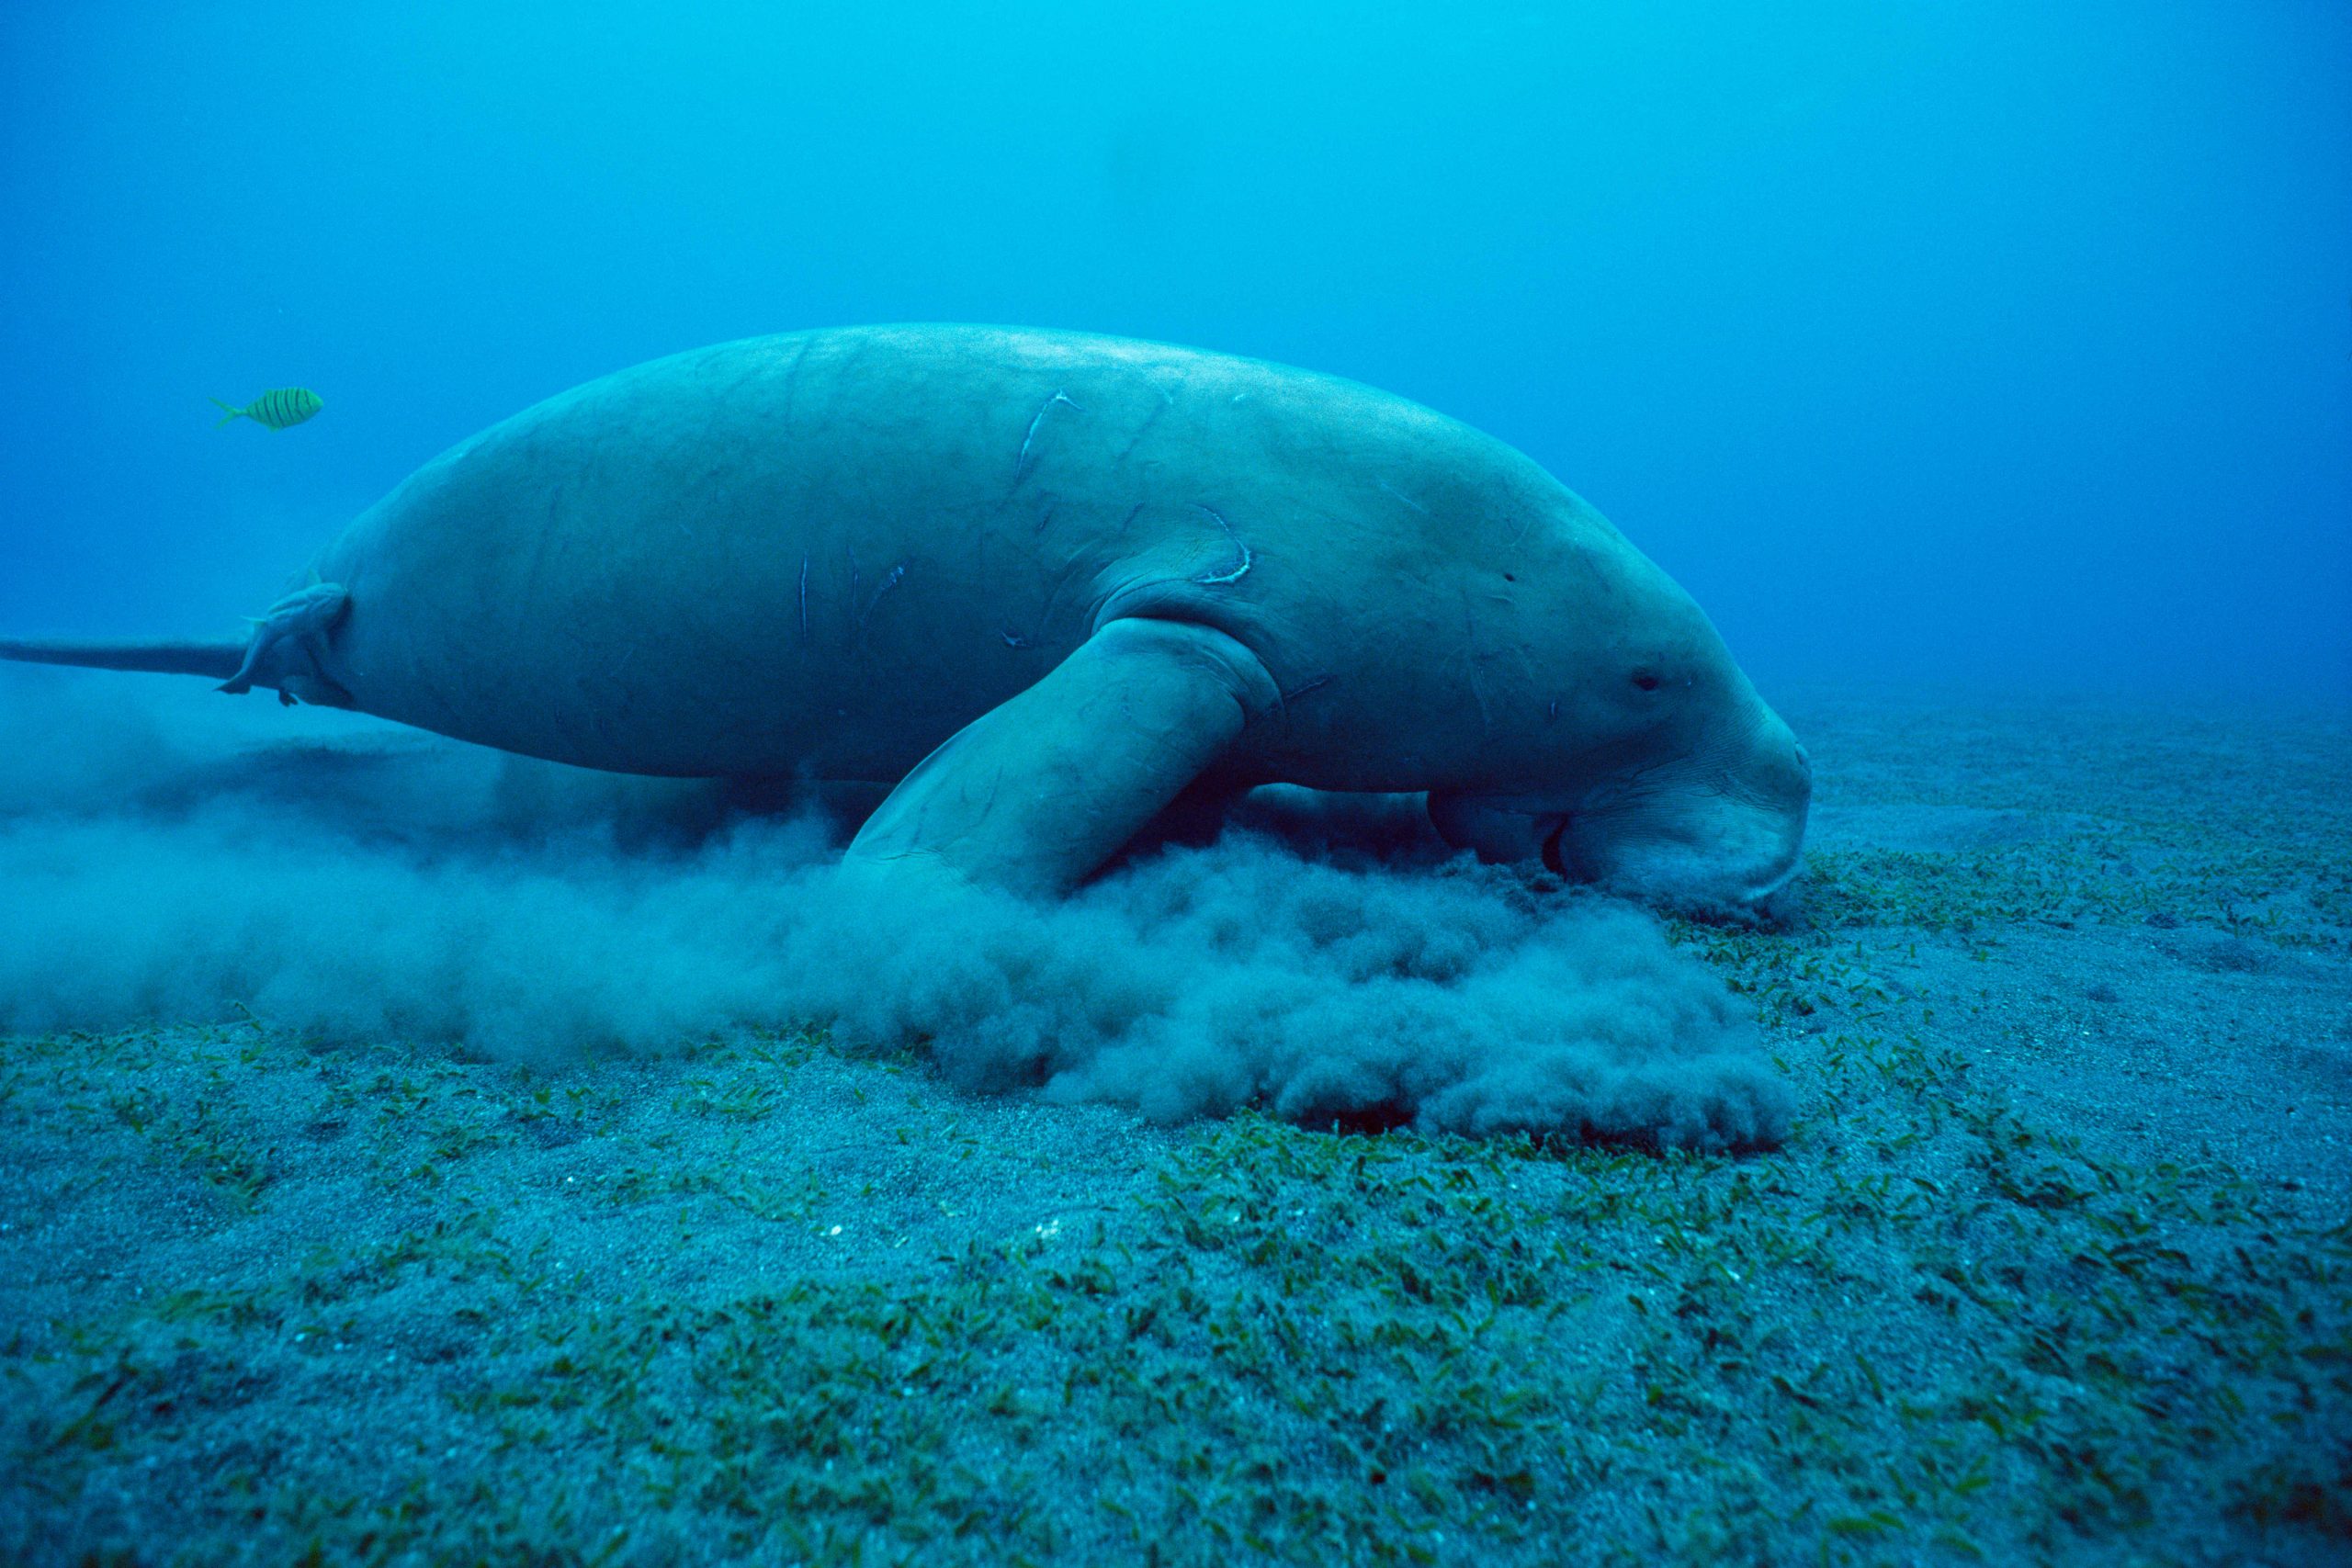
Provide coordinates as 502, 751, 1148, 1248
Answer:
849, 621, 1277, 894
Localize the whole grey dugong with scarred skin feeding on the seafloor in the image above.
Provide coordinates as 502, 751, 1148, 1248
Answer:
0, 327, 1811, 900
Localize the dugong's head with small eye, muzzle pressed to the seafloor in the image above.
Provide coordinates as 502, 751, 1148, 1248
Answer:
1430, 503, 1814, 905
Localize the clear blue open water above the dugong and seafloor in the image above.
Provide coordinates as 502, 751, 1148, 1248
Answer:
0, 0, 2352, 698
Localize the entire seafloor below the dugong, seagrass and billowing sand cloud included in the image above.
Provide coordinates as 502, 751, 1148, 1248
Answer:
0, 672, 2352, 1563
